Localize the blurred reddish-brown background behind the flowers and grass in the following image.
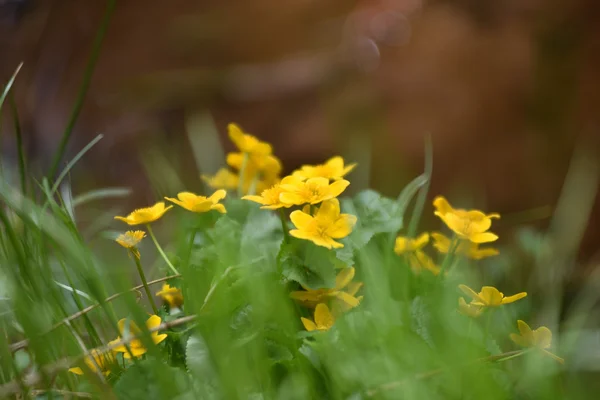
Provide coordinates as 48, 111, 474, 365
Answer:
0, 0, 600, 259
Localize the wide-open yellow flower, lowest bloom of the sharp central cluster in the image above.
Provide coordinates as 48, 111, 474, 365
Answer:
290, 199, 356, 249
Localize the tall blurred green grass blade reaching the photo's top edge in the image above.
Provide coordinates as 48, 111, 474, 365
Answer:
47, 0, 117, 179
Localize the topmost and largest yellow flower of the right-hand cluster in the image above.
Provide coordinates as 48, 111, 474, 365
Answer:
433, 196, 500, 243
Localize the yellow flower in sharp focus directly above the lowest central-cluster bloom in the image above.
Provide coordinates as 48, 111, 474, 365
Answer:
279, 176, 350, 205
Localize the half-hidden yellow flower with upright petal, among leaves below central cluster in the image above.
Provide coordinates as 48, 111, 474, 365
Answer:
290, 267, 362, 308
